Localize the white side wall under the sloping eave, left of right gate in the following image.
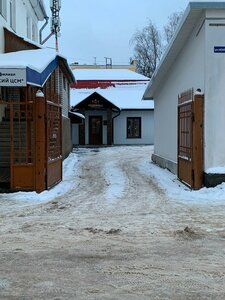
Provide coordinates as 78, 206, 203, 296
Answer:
154, 14, 205, 166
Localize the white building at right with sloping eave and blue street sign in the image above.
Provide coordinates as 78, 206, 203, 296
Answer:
144, 2, 225, 187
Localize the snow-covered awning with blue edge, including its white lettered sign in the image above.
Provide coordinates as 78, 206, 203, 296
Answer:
0, 49, 75, 87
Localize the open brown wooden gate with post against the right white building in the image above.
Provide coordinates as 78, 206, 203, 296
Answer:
177, 90, 204, 189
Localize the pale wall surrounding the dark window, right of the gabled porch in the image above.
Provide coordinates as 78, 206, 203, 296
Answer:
114, 110, 154, 145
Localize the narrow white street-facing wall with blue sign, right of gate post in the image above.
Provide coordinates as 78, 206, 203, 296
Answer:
204, 11, 225, 170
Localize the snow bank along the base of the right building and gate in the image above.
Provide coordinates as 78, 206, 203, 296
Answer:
139, 161, 225, 205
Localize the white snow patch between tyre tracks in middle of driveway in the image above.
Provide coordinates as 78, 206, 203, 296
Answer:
103, 161, 126, 201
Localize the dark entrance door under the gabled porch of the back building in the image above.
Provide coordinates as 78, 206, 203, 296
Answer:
89, 116, 102, 145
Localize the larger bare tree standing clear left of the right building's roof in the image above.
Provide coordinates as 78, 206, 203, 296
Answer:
131, 20, 162, 78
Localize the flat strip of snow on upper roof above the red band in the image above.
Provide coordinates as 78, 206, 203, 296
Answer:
73, 69, 149, 81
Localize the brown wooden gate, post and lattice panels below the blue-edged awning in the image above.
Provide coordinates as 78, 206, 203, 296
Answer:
0, 88, 62, 192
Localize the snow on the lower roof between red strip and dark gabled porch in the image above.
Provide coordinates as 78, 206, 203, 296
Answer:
70, 85, 154, 110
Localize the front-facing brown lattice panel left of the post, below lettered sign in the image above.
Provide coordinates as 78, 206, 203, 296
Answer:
0, 92, 35, 190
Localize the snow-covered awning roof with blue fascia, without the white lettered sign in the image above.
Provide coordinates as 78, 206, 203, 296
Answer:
0, 48, 73, 86
